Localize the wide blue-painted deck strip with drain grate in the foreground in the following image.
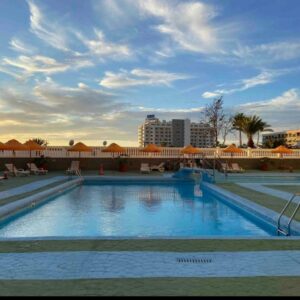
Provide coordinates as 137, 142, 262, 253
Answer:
0, 251, 300, 280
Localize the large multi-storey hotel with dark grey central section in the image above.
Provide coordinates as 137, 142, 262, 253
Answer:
138, 115, 214, 148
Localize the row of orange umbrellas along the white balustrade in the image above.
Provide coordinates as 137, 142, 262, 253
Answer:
0, 139, 293, 156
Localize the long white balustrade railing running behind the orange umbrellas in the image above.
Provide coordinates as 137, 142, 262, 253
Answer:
0, 146, 300, 159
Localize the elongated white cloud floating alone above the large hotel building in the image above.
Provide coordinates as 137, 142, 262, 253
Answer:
100, 69, 189, 89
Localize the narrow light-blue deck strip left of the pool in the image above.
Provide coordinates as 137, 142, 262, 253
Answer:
0, 176, 67, 200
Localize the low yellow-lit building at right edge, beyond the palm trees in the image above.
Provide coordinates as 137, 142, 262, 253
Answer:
263, 129, 300, 147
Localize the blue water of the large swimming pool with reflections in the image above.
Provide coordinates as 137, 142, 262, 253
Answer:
0, 183, 272, 238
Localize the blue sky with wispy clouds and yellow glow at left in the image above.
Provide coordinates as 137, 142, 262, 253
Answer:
0, 0, 300, 146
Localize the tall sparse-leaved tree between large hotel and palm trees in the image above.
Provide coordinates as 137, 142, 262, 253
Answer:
203, 96, 225, 147
